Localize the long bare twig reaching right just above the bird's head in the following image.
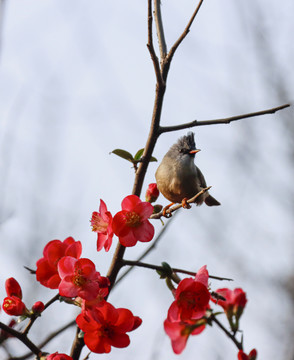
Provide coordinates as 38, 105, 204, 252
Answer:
159, 104, 291, 134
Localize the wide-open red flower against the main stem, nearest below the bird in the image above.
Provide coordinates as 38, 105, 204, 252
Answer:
112, 195, 154, 246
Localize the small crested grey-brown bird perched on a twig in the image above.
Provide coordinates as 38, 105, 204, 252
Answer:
155, 132, 220, 206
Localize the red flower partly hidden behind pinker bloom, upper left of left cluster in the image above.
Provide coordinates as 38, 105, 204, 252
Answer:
36, 237, 82, 289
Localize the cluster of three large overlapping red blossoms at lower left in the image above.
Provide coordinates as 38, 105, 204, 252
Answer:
35, 229, 142, 352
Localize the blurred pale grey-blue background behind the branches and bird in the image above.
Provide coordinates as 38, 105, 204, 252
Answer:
0, 0, 294, 360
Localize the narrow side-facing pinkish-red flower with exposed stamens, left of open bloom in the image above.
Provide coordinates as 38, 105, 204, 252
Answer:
91, 199, 113, 251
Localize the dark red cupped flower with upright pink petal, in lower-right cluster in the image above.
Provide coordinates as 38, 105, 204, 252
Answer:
170, 266, 210, 321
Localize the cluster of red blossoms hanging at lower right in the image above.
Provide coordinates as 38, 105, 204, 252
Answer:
164, 266, 257, 360
